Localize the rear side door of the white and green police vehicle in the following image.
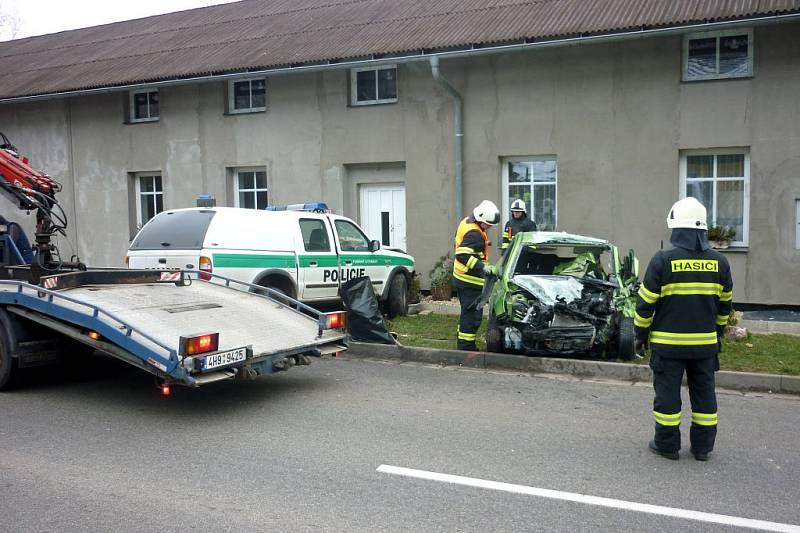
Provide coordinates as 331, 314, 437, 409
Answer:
297, 217, 339, 300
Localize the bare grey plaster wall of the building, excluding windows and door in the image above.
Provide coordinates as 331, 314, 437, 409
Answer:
0, 24, 800, 304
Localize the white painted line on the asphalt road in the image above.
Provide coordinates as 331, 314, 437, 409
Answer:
377, 465, 800, 533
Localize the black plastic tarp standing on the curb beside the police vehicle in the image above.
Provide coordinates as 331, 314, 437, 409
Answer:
339, 276, 395, 344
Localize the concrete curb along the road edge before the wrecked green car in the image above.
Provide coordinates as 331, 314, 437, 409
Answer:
344, 342, 800, 395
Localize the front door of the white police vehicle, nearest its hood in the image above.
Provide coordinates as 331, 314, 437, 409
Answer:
333, 218, 384, 294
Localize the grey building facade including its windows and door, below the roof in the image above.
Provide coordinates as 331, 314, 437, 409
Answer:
0, 15, 800, 305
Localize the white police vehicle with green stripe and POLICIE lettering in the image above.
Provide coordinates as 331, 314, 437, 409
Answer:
126, 204, 414, 316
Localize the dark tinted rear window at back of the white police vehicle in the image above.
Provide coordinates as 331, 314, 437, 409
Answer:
130, 210, 215, 250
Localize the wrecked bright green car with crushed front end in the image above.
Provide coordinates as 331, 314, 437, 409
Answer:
482, 231, 639, 360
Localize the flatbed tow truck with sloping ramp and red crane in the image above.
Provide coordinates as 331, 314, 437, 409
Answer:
0, 133, 347, 395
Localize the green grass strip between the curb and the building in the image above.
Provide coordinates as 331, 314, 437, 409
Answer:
387, 314, 800, 375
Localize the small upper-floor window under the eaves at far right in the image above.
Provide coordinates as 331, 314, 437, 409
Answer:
683, 29, 753, 81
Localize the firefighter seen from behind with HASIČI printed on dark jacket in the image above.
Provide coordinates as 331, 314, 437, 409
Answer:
634, 197, 733, 461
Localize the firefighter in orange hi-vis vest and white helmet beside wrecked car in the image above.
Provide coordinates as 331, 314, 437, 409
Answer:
453, 200, 500, 351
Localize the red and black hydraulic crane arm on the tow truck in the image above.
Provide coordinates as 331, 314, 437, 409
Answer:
0, 132, 86, 283
